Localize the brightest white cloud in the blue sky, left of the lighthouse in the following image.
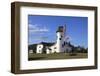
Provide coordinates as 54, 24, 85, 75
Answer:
29, 24, 49, 32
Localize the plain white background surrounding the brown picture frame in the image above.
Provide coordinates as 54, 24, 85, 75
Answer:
0, 0, 100, 76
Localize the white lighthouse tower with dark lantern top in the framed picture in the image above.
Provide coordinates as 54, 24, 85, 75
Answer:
56, 26, 65, 53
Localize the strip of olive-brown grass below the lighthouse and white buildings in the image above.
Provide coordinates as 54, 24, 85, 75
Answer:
28, 53, 88, 60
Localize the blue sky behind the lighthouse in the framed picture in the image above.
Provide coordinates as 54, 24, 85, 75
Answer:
28, 15, 88, 47
